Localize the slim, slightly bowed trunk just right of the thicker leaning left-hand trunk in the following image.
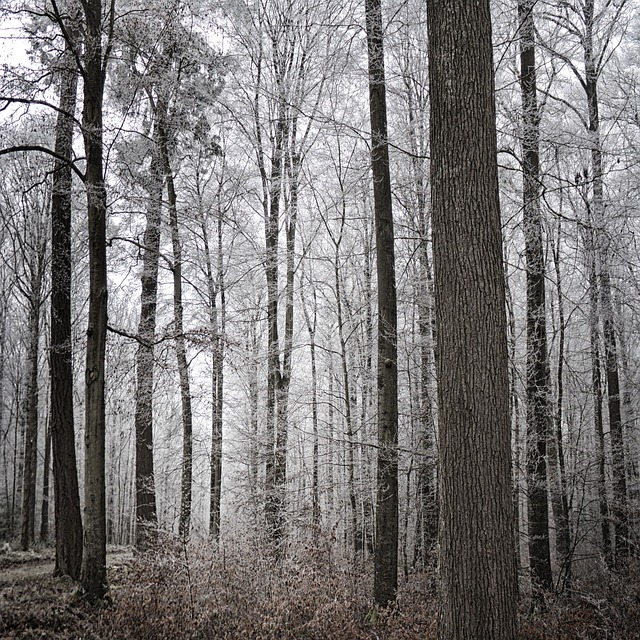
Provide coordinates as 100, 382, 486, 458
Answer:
159, 124, 193, 538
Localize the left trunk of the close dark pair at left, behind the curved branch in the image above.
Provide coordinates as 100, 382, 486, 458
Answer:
49, 35, 83, 580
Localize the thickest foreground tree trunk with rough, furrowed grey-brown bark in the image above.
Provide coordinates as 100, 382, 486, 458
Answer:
427, 0, 518, 640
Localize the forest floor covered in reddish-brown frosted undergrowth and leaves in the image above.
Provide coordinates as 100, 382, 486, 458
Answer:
0, 542, 640, 640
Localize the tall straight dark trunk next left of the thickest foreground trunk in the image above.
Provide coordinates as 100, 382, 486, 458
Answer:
365, 0, 398, 607
